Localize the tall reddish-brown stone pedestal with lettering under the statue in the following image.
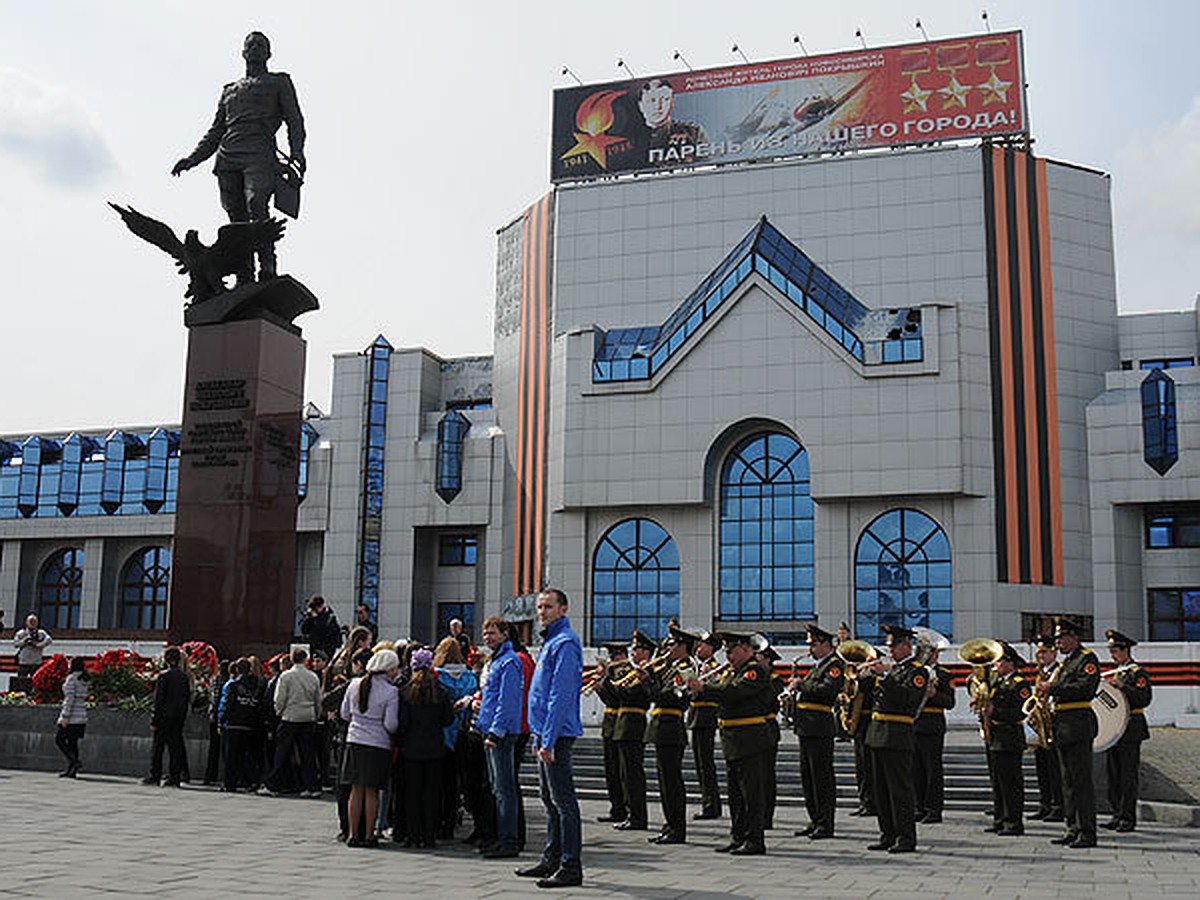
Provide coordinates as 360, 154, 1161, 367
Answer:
169, 318, 305, 656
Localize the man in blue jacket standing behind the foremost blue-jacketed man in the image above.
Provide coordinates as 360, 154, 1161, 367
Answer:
475, 617, 524, 859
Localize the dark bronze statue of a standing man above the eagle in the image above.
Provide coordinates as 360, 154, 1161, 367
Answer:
170, 31, 306, 284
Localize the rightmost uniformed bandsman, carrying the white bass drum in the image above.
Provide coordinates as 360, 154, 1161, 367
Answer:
1104, 628, 1153, 832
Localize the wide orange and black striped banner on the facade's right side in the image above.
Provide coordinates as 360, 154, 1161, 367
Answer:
983, 144, 1062, 584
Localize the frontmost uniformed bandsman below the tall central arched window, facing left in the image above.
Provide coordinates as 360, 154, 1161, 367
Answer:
688, 632, 775, 856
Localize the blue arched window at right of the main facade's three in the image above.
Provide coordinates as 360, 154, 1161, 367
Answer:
854, 509, 953, 642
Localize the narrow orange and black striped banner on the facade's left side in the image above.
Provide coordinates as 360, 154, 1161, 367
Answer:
512, 193, 554, 596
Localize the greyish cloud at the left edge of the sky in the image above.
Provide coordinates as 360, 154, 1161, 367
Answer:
0, 67, 116, 187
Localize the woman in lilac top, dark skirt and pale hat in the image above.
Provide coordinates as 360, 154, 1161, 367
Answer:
341, 649, 400, 847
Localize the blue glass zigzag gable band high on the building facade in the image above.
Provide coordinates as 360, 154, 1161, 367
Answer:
592, 216, 924, 383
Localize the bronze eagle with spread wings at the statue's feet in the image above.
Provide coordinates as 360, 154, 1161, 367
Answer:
108, 203, 283, 304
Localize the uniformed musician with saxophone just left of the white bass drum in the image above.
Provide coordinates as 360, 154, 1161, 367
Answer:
1036, 618, 1100, 847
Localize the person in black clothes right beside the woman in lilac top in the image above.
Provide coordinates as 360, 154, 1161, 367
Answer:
400, 648, 454, 848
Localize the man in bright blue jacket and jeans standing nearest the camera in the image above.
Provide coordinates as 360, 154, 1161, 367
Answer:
516, 588, 583, 888
